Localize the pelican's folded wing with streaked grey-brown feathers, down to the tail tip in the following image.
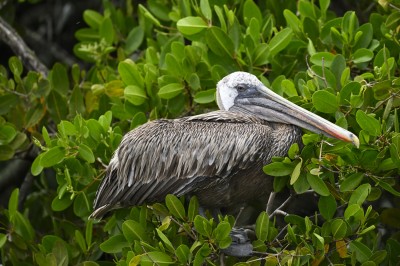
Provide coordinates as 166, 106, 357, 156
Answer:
92, 111, 271, 217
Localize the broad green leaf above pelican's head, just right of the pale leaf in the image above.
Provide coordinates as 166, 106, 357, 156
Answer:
206, 27, 235, 58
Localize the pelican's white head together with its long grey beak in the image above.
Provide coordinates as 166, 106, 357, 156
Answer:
217, 72, 360, 147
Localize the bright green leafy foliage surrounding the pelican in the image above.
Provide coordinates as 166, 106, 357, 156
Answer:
0, 0, 400, 265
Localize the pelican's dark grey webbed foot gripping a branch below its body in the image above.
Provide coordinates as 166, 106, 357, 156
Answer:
222, 228, 253, 257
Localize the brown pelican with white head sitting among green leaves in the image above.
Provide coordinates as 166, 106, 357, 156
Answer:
91, 72, 359, 218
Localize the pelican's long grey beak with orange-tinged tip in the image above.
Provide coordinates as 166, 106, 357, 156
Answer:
232, 84, 360, 148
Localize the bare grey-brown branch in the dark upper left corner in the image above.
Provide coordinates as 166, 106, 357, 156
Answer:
0, 17, 49, 77
